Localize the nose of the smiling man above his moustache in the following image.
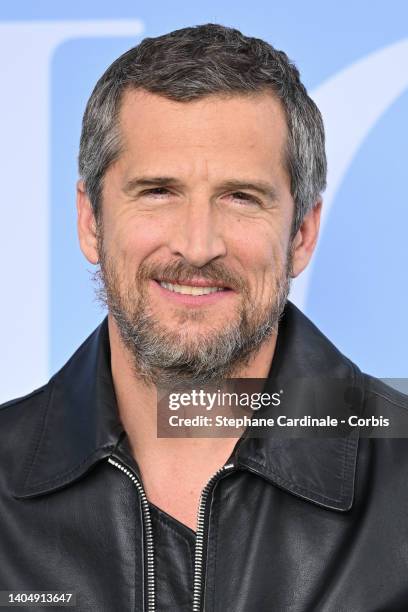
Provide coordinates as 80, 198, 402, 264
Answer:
169, 195, 227, 268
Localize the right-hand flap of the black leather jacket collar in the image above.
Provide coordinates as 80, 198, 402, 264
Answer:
237, 302, 364, 511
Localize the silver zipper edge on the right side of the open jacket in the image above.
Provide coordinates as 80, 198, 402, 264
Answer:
193, 463, 235, 612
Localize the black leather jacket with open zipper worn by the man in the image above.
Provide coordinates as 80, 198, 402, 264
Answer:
0, 303, 408, 612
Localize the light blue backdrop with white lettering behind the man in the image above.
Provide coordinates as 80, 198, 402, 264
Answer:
0, 0, 408, 402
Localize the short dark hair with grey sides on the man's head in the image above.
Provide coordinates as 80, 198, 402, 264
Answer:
79, 23, 327, 235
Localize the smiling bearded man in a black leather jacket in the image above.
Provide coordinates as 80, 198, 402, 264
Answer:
0, 24, 408, 612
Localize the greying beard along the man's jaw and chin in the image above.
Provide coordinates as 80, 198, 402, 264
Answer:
96, 239, 291, 389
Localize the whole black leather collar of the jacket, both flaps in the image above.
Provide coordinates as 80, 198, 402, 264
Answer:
14, 302, 362, 510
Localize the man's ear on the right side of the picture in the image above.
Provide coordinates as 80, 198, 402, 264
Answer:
291, 200, 322, 278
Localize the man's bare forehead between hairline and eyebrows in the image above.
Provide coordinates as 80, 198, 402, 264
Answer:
115, 90, 287, 179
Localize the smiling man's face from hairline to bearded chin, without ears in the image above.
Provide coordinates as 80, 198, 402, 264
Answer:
90, 90, 300, 384
